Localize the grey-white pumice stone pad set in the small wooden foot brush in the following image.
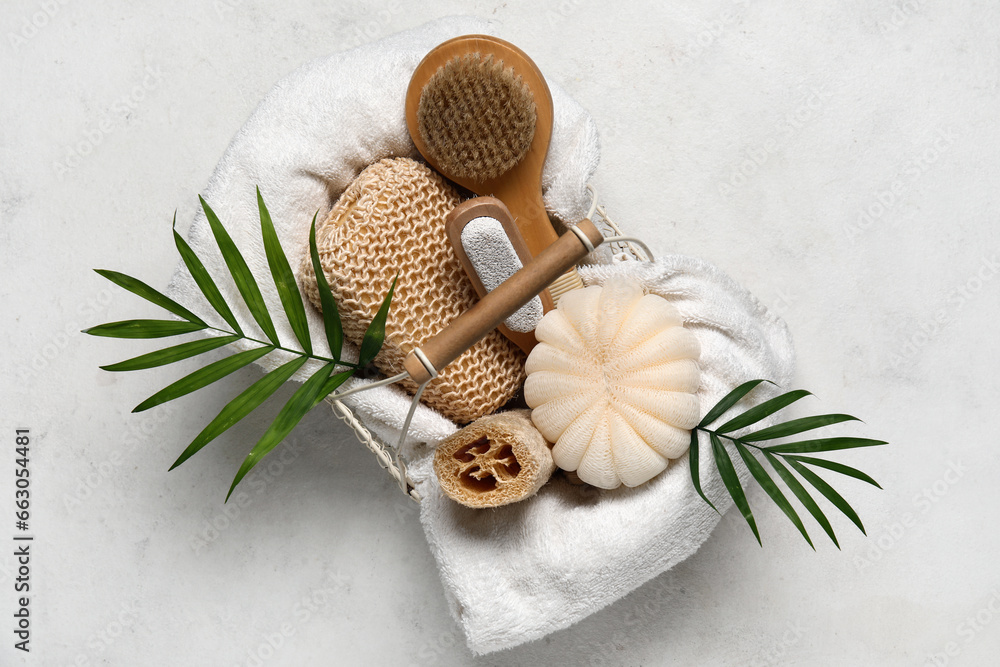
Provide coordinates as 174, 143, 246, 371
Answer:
462, 218, 542, 333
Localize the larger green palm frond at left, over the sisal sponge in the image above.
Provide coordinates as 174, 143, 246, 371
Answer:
84, 188, 398, 500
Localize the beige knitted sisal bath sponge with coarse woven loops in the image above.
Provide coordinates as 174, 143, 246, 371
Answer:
299, 158, 524, 423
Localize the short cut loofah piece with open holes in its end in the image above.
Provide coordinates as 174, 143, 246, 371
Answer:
434, 410, 555, 507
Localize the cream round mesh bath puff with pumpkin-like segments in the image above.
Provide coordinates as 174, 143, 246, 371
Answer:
524, 277, 700, 489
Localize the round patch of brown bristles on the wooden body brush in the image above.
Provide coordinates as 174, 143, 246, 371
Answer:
417, 53, 536, 183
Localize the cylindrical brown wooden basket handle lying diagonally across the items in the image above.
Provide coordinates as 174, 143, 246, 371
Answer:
403, 220, 604, 384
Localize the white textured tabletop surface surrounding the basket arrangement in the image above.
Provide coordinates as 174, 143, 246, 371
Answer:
0, 0, 1000, 665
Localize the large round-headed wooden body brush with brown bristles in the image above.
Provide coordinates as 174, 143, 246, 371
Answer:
406, 35, 583, 322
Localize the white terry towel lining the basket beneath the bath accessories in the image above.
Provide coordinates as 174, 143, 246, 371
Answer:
162, 18, 793, 653
